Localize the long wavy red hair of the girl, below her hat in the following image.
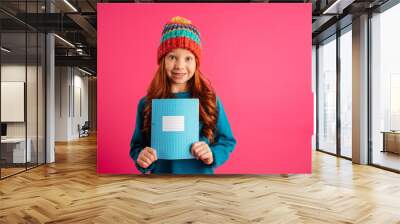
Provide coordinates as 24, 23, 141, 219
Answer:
141, 57, 217, 143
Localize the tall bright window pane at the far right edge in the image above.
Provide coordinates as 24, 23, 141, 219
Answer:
370, 4, 400, 170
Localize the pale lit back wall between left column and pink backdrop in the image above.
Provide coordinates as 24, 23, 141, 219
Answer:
55, 67, 89, 141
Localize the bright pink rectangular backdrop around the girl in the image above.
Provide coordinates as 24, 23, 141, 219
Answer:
97, 3, 313, 174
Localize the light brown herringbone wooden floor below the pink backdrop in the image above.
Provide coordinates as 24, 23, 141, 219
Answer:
0, 134, 400, 224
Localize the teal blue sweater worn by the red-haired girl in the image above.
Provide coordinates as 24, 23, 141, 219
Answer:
130, 92, 236, 174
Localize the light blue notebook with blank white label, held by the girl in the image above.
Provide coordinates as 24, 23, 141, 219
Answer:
151, 99, 199, 160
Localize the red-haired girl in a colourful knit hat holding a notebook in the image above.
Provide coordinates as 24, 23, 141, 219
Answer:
130, 17, 236, 174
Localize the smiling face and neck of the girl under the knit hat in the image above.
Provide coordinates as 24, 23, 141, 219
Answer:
164, 48, 196, 92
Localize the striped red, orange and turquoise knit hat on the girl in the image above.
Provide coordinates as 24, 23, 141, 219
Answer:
157, 16, 201, 64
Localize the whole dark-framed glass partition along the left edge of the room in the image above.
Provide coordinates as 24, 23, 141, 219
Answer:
0, 1, 46, 179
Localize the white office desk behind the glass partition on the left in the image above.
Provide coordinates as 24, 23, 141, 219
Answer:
1, 138, 32, 163
